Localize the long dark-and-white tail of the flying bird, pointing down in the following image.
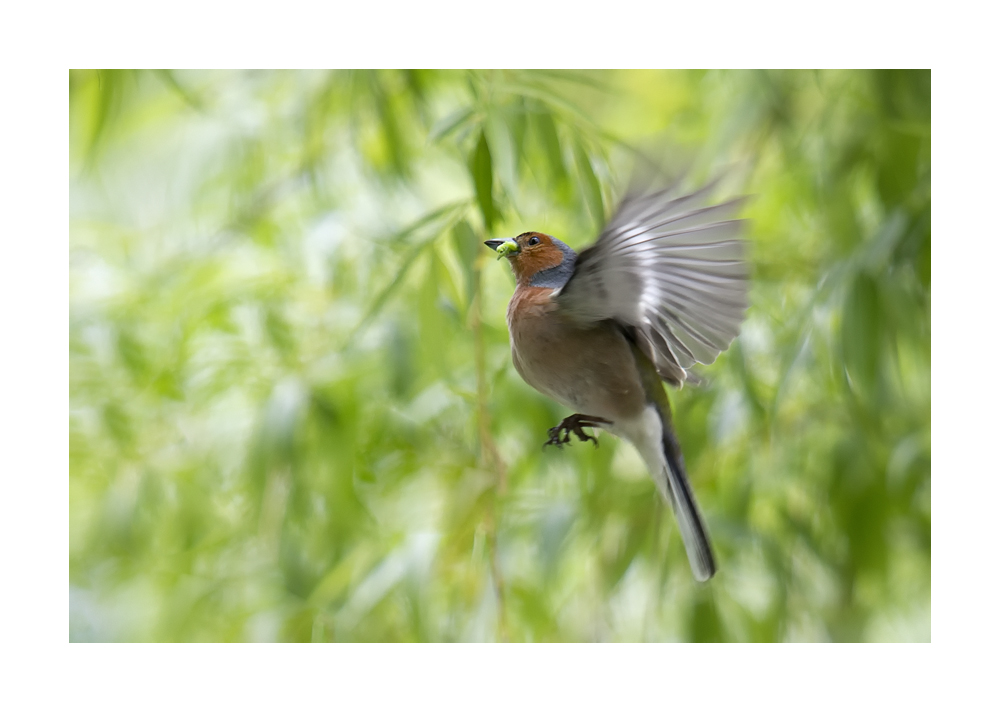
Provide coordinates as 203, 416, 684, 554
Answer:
654, 408, 715, 581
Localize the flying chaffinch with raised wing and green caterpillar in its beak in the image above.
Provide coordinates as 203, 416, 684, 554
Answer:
485, 177, 749, 582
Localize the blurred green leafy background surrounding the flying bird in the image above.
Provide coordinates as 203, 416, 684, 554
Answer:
69, 70, 931, 641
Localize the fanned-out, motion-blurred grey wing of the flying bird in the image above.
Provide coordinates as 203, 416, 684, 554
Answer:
556, 181, 748, 385
